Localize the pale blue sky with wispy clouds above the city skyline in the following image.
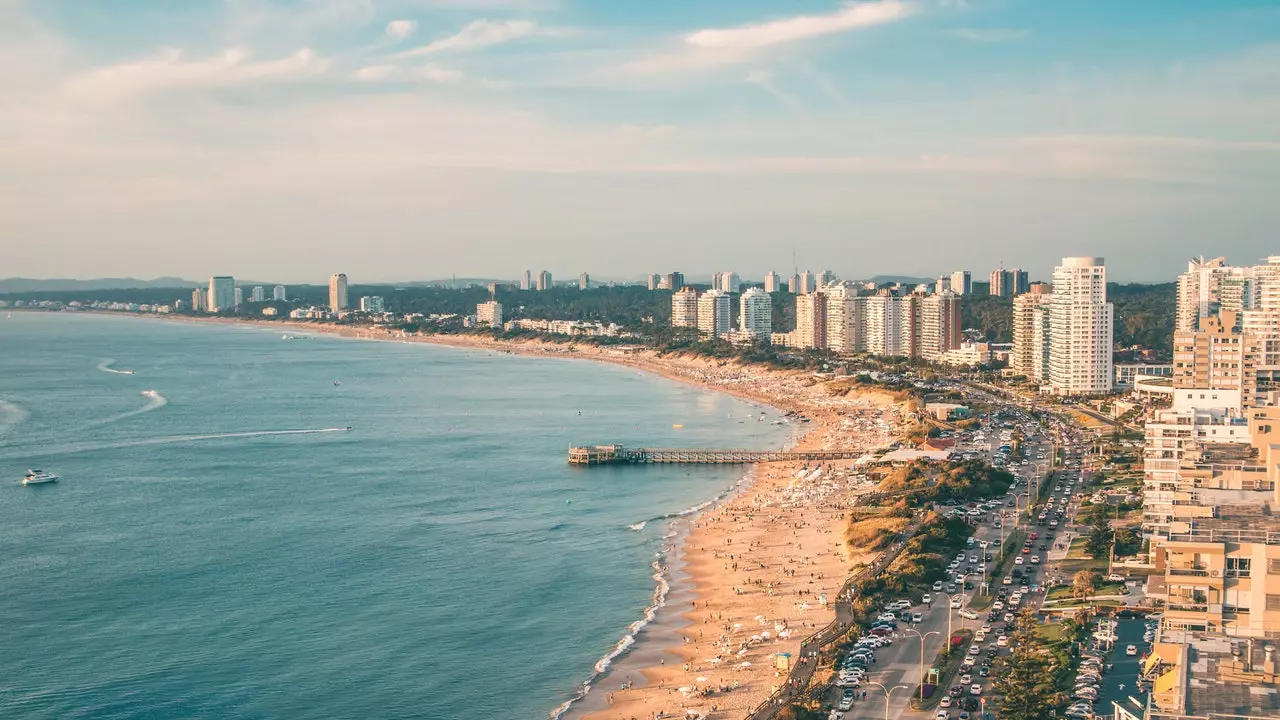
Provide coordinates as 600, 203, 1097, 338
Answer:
0, 0, 1280, 283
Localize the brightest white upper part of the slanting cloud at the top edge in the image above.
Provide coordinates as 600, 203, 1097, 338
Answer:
685, 0, 916, 50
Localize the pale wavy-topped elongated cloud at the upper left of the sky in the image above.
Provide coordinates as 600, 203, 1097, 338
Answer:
65, 47, 329, 100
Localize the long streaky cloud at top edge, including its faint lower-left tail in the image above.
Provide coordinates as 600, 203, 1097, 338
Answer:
623, 0, 919, 74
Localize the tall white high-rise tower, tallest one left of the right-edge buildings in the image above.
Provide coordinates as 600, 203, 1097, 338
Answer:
1048, 258, 1115, 395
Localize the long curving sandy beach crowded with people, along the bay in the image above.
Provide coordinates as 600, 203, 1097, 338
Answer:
42, 313, 901, 720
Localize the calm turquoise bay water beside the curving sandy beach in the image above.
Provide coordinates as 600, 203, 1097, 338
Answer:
0, 314, 783, 720
